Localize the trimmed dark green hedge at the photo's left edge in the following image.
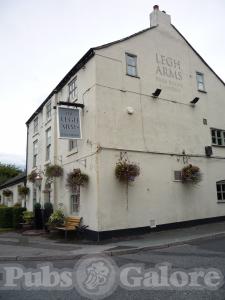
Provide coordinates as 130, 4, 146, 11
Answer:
0, 207, 26, 228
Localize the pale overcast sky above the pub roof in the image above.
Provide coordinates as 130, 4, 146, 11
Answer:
0, 0, 225, 166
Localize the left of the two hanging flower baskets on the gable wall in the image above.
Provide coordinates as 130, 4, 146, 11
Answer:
115, 160, 140, 182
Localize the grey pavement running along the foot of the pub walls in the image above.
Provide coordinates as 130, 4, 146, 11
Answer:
0, 222, 225, 261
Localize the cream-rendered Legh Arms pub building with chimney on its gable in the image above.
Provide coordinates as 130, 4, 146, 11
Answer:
27, 6, 225, 238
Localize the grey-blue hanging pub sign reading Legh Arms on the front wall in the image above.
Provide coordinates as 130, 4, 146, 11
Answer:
57, 106, 82, 140
